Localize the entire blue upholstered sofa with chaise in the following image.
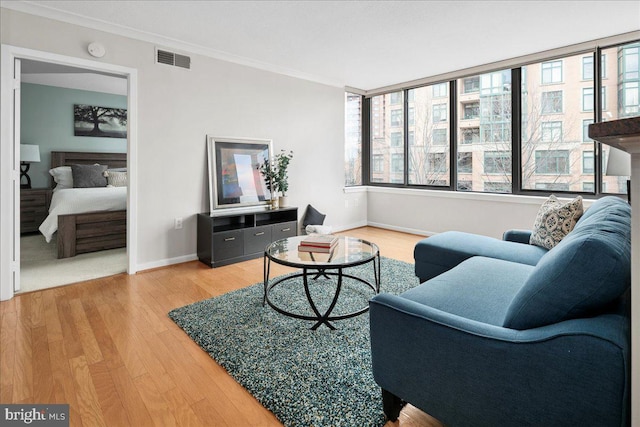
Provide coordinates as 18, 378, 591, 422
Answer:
370, 197, 631, 427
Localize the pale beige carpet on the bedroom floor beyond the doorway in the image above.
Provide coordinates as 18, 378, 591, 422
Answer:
20, 234, 127, 292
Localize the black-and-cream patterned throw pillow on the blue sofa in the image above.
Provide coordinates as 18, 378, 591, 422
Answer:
529, 194, 584, 249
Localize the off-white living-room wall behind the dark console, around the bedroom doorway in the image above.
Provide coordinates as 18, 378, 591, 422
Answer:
0, 9, 366, 269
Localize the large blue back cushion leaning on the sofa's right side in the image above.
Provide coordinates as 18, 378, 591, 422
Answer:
503, 197, 631, 329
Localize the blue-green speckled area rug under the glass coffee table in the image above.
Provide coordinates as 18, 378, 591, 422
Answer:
169, 257, 418, 427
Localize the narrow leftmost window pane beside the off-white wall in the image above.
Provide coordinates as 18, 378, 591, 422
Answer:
344, 92, 362, 186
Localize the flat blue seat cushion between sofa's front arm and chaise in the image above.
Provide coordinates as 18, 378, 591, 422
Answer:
400, 256, 534, 326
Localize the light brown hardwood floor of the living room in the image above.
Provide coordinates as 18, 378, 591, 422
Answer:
0, 227, 440, 427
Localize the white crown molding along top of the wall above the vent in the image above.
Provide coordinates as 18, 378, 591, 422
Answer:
0, 1, 344, 88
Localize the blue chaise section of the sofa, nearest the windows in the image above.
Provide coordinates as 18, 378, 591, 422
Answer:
413, 231, 547, 281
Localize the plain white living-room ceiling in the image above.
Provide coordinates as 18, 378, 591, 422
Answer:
1, 0, 640, 90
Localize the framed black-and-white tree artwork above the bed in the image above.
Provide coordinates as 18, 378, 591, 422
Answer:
73, 104, 127, 138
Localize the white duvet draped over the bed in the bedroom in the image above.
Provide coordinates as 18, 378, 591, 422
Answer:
39, 187, 127, 242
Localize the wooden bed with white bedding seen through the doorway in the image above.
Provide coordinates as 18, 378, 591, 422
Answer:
39, 151, 127, 258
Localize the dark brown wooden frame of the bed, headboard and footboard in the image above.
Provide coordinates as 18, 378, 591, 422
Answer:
51, 151, 127, 258
